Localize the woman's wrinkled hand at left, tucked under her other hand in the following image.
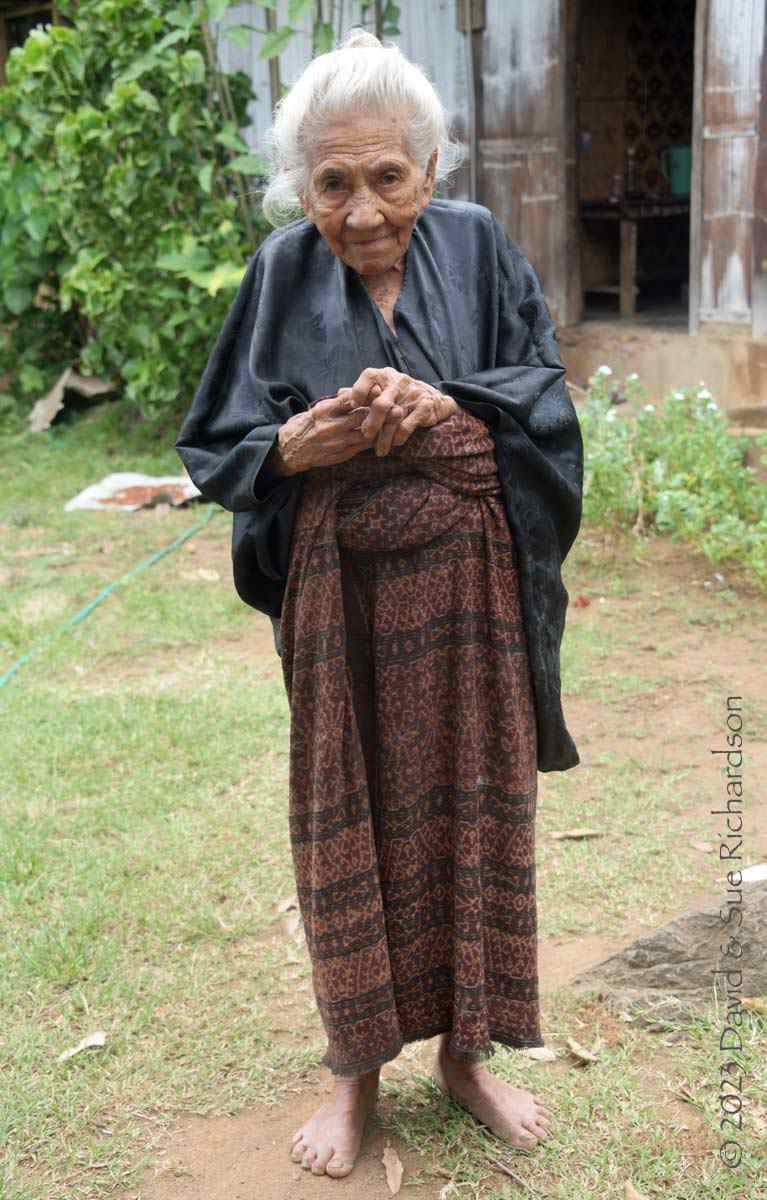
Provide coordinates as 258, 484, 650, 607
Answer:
276, 388, 370, 475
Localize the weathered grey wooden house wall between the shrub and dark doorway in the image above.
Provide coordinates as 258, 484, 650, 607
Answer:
213, 0, 567, 319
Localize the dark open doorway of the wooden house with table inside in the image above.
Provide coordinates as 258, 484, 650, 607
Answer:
576, 0, 695, 326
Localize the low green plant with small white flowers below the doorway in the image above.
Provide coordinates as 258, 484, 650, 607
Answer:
579, 366, 767, 587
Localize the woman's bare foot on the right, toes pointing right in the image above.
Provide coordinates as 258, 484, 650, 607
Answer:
433, 1034, 551, 1150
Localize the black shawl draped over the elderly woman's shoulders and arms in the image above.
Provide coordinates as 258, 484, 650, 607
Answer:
175, 199, 583, 770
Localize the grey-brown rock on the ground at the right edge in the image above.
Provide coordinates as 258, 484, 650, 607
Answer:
573, 881, 767, 1024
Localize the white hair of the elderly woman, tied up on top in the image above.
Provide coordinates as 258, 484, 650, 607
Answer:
262, 29, 463, 226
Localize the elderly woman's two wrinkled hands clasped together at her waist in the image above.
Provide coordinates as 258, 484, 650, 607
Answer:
278, 367, 459, 473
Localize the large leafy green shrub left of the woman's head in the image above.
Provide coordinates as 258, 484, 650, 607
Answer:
0, 0, 268, 432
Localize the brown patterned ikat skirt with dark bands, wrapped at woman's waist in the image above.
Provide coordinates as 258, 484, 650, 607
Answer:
282, 409, 544, 1075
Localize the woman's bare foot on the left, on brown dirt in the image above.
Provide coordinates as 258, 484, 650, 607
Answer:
290, 1070, 379, 1180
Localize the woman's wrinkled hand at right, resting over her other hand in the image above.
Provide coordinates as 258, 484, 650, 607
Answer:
338, 367, 460, 455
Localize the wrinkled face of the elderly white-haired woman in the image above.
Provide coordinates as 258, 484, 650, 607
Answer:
300, 113, 437, 276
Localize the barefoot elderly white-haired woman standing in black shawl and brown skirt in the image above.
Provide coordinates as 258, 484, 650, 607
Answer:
176, 31, 582, 1177
